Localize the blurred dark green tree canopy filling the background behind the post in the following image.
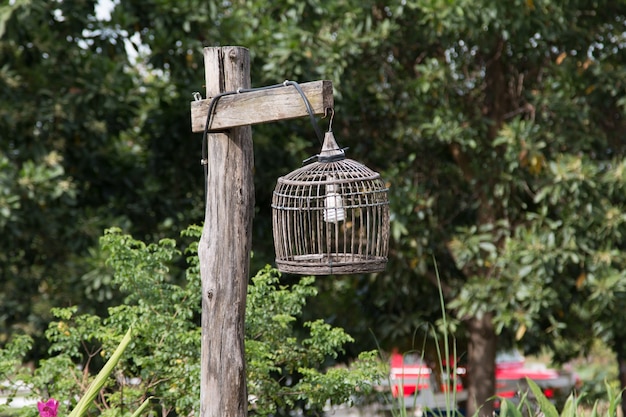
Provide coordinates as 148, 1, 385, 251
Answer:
0, 0, 626, 413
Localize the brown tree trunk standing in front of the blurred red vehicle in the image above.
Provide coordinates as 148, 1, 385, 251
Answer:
466, 314, 497, 417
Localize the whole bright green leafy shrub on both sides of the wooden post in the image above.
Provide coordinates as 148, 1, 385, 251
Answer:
0, 227, 384, 416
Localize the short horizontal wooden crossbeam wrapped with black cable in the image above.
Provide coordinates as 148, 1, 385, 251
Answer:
191, 80, 334, 133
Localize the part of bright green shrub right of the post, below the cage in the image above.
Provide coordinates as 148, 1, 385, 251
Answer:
246, 267, 384, 415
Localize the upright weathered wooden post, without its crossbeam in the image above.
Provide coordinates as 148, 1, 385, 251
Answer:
198, 47, 254, 417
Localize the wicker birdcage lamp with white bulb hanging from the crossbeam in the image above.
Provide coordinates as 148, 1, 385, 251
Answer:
272, 131, 389, 275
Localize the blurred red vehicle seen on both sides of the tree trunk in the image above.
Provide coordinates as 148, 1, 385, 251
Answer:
390, 351, 580, 408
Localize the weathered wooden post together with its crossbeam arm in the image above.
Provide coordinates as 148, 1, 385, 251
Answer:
191, 46, 333, 417
